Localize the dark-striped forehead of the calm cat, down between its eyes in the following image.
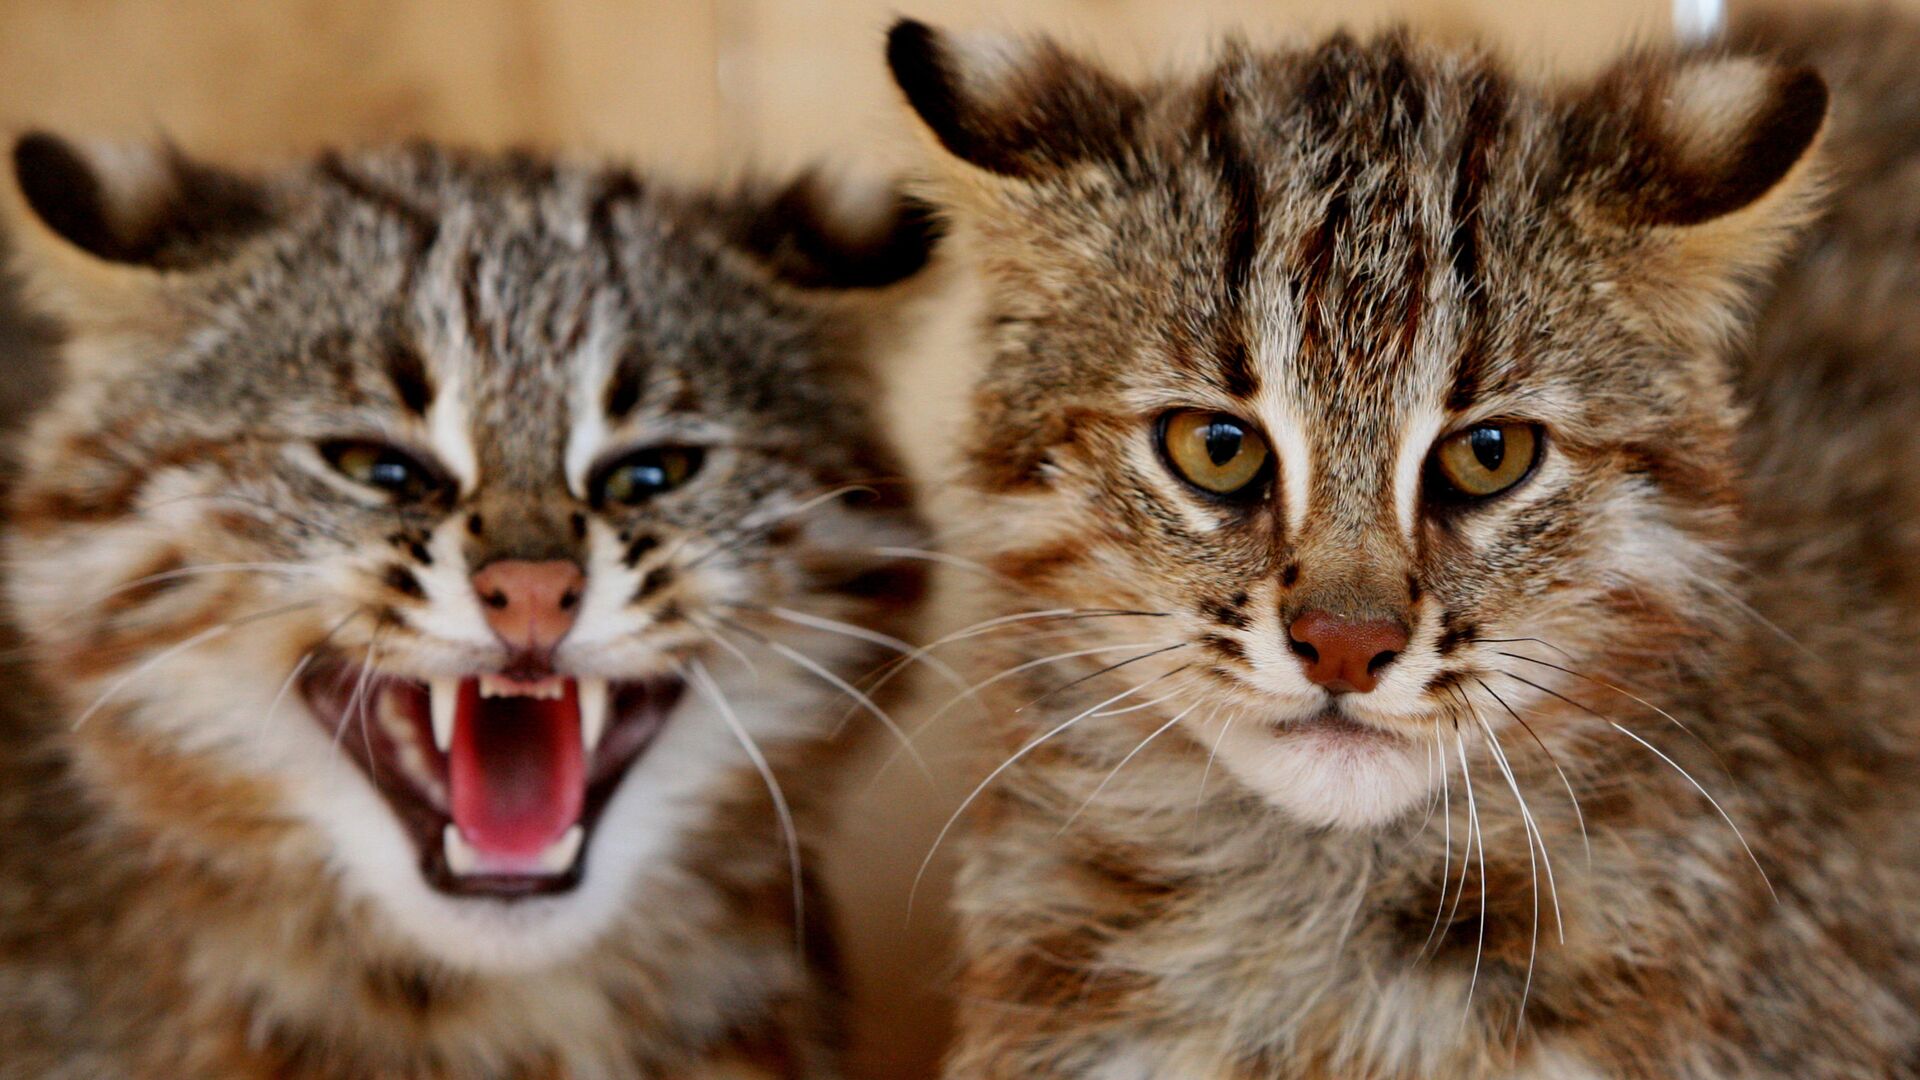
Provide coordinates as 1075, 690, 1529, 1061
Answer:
1175, 38, 1511, 525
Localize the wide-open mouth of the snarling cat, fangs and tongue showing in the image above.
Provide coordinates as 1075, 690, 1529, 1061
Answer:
301, 661, 682, 897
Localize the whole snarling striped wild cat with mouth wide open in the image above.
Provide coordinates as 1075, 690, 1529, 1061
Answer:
0, 135, 929, 1078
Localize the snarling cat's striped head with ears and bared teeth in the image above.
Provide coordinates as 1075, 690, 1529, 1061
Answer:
10, 136, 925, 967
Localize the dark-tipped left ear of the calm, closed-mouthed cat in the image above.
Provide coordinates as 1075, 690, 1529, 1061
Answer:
887, 19, 1144, 179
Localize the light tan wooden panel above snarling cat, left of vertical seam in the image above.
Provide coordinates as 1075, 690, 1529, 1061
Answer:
0, 0, 722, 169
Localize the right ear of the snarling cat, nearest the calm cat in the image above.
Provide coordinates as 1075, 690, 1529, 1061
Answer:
710, 173, 941, 288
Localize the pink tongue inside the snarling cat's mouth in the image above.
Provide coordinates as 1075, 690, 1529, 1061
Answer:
447, 678, 586, 859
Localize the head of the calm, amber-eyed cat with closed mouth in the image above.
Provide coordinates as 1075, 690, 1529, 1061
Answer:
889, 21, 1826, 826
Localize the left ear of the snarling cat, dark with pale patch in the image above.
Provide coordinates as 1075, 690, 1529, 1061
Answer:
0, 133, 265, 331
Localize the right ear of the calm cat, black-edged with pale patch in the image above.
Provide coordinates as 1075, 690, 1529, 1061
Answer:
1567, 54, 1828, 329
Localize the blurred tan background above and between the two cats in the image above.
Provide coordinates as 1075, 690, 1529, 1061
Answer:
0, 0, 1873, 1078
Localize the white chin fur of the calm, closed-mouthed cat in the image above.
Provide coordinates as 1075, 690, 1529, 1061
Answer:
1219, 724, 1432, 828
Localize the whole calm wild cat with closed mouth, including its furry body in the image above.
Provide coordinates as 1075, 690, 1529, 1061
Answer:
889, 13, 1920, 1080
